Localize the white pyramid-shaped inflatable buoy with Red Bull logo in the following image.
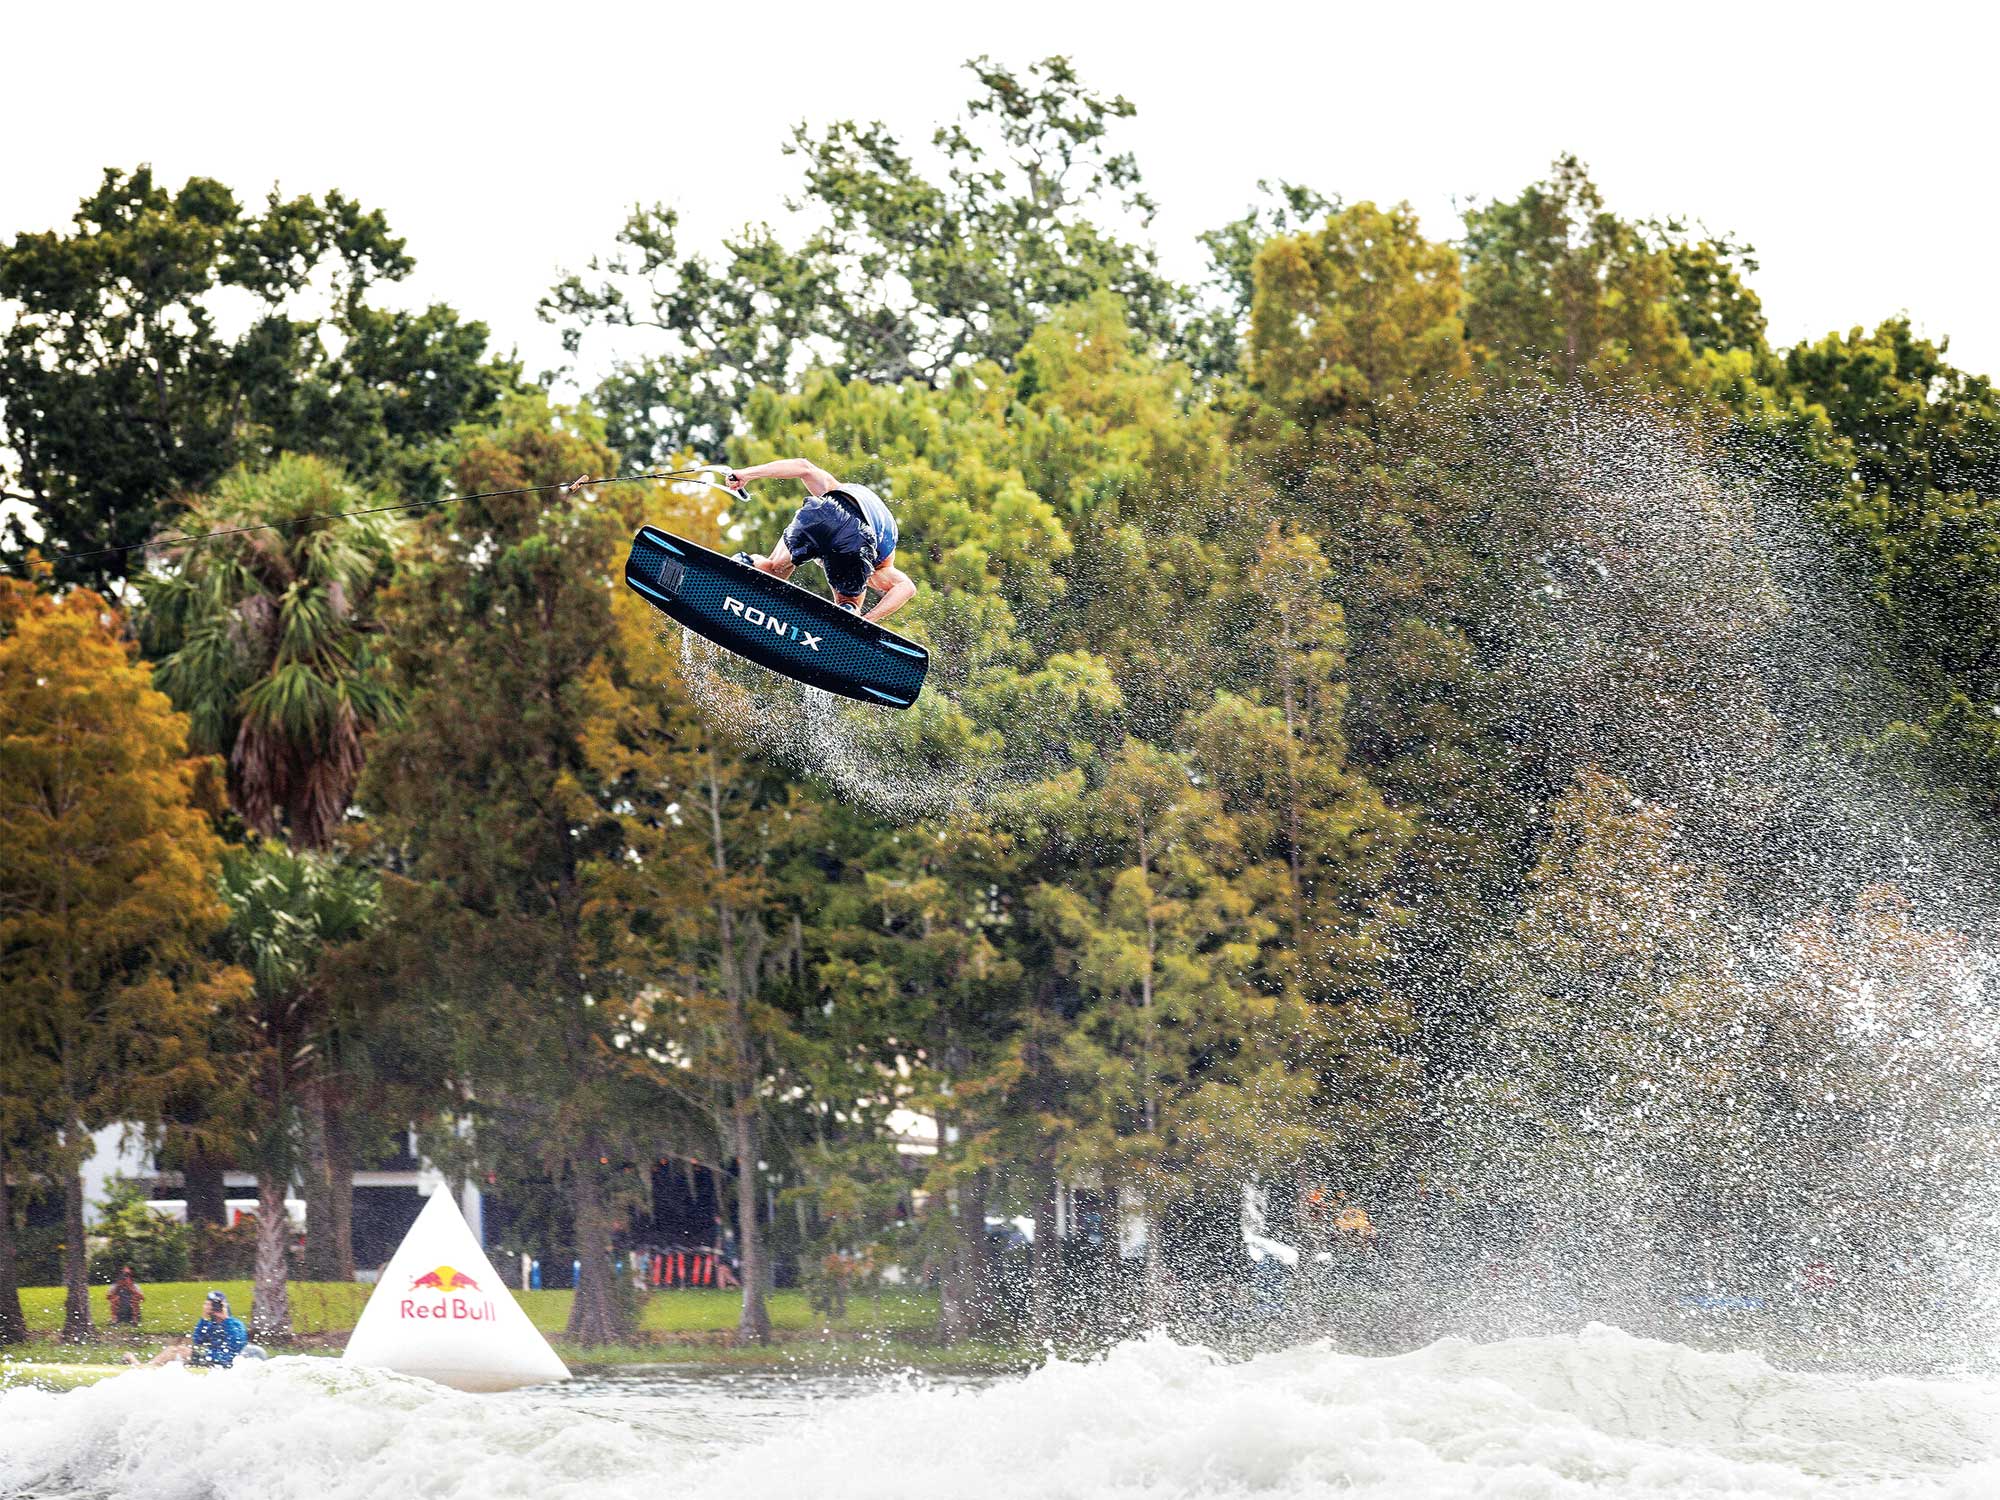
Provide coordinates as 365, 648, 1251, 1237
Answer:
342, 1188, 570, 1390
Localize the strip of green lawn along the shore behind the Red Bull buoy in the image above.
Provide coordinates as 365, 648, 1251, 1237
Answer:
0, 1282, 976, 1382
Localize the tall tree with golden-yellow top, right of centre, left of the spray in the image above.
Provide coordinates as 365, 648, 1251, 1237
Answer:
1232, 238, 1534, 1120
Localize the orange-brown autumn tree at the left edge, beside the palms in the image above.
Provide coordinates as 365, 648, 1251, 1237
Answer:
0, 580, 244, 1338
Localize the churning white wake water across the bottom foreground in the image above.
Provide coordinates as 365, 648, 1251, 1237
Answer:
0, 1326, 2000, 1500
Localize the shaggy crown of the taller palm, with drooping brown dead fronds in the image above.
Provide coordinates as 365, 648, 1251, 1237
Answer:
138, 454, 396, 850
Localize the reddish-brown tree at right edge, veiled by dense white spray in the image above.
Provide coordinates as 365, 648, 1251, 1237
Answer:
1736, 884, 1996, 1320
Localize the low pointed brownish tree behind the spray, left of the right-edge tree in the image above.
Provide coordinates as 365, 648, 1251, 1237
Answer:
1454, 768, 1736, 1244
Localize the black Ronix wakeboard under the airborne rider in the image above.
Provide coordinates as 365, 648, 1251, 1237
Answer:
626, 526, 930, 708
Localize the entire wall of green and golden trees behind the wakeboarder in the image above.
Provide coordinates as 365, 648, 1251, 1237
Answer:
0, 76, 2000, 1342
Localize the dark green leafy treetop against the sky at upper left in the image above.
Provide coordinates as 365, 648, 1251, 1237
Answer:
0, 166, 518, 588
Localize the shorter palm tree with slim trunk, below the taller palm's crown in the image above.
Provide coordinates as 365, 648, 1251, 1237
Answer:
222, 842, 380, 1338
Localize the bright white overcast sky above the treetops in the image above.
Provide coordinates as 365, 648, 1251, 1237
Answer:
11, 0, 2000, 388
